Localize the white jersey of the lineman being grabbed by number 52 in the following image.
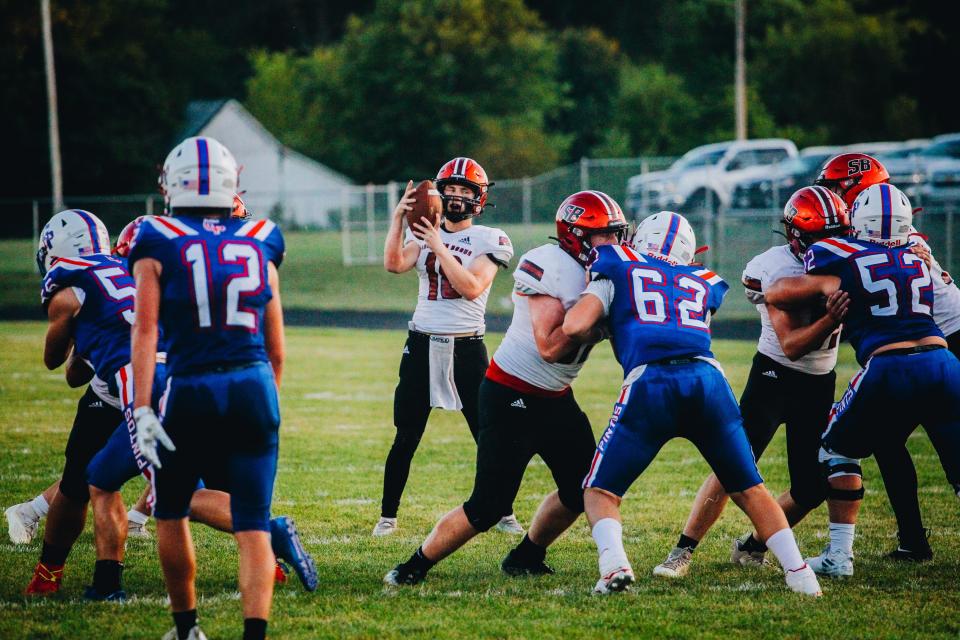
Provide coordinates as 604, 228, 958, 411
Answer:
743, 245, 840, 375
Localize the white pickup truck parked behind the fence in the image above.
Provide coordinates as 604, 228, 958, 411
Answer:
626, 138, 799, 216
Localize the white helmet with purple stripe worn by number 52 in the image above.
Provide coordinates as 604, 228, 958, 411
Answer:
850, 184, 913, 247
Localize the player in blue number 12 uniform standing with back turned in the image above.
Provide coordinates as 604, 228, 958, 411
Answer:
129, 137, 284, 640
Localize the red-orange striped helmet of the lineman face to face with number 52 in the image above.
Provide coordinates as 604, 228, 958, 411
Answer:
783, 185, 850, 257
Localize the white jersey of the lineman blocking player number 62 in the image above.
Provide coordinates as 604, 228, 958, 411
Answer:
493, 244, 589, 391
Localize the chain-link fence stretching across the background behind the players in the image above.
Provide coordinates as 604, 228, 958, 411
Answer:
7, 157, 960, 302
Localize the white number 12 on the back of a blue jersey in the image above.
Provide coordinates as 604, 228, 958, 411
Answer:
183, 242, 264, 331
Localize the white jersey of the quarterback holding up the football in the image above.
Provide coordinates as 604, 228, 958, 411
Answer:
407, 224, 513, 335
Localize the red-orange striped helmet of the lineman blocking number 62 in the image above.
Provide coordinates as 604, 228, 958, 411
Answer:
557, 191, 629, 266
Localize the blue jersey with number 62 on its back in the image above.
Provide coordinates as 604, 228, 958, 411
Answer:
587, 245, 729, 374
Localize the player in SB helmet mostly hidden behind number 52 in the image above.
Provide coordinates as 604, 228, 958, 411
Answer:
816, 153, 960, 561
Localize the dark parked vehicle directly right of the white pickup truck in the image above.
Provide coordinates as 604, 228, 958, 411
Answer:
731, 147, 840, 209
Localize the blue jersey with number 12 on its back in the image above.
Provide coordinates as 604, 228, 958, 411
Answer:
130, 216, 284, 375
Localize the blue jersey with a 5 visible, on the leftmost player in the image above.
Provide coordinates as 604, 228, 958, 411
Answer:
40, 254, 136, 384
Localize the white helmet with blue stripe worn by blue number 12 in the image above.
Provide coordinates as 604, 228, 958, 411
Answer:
159, 137, 240, 213
